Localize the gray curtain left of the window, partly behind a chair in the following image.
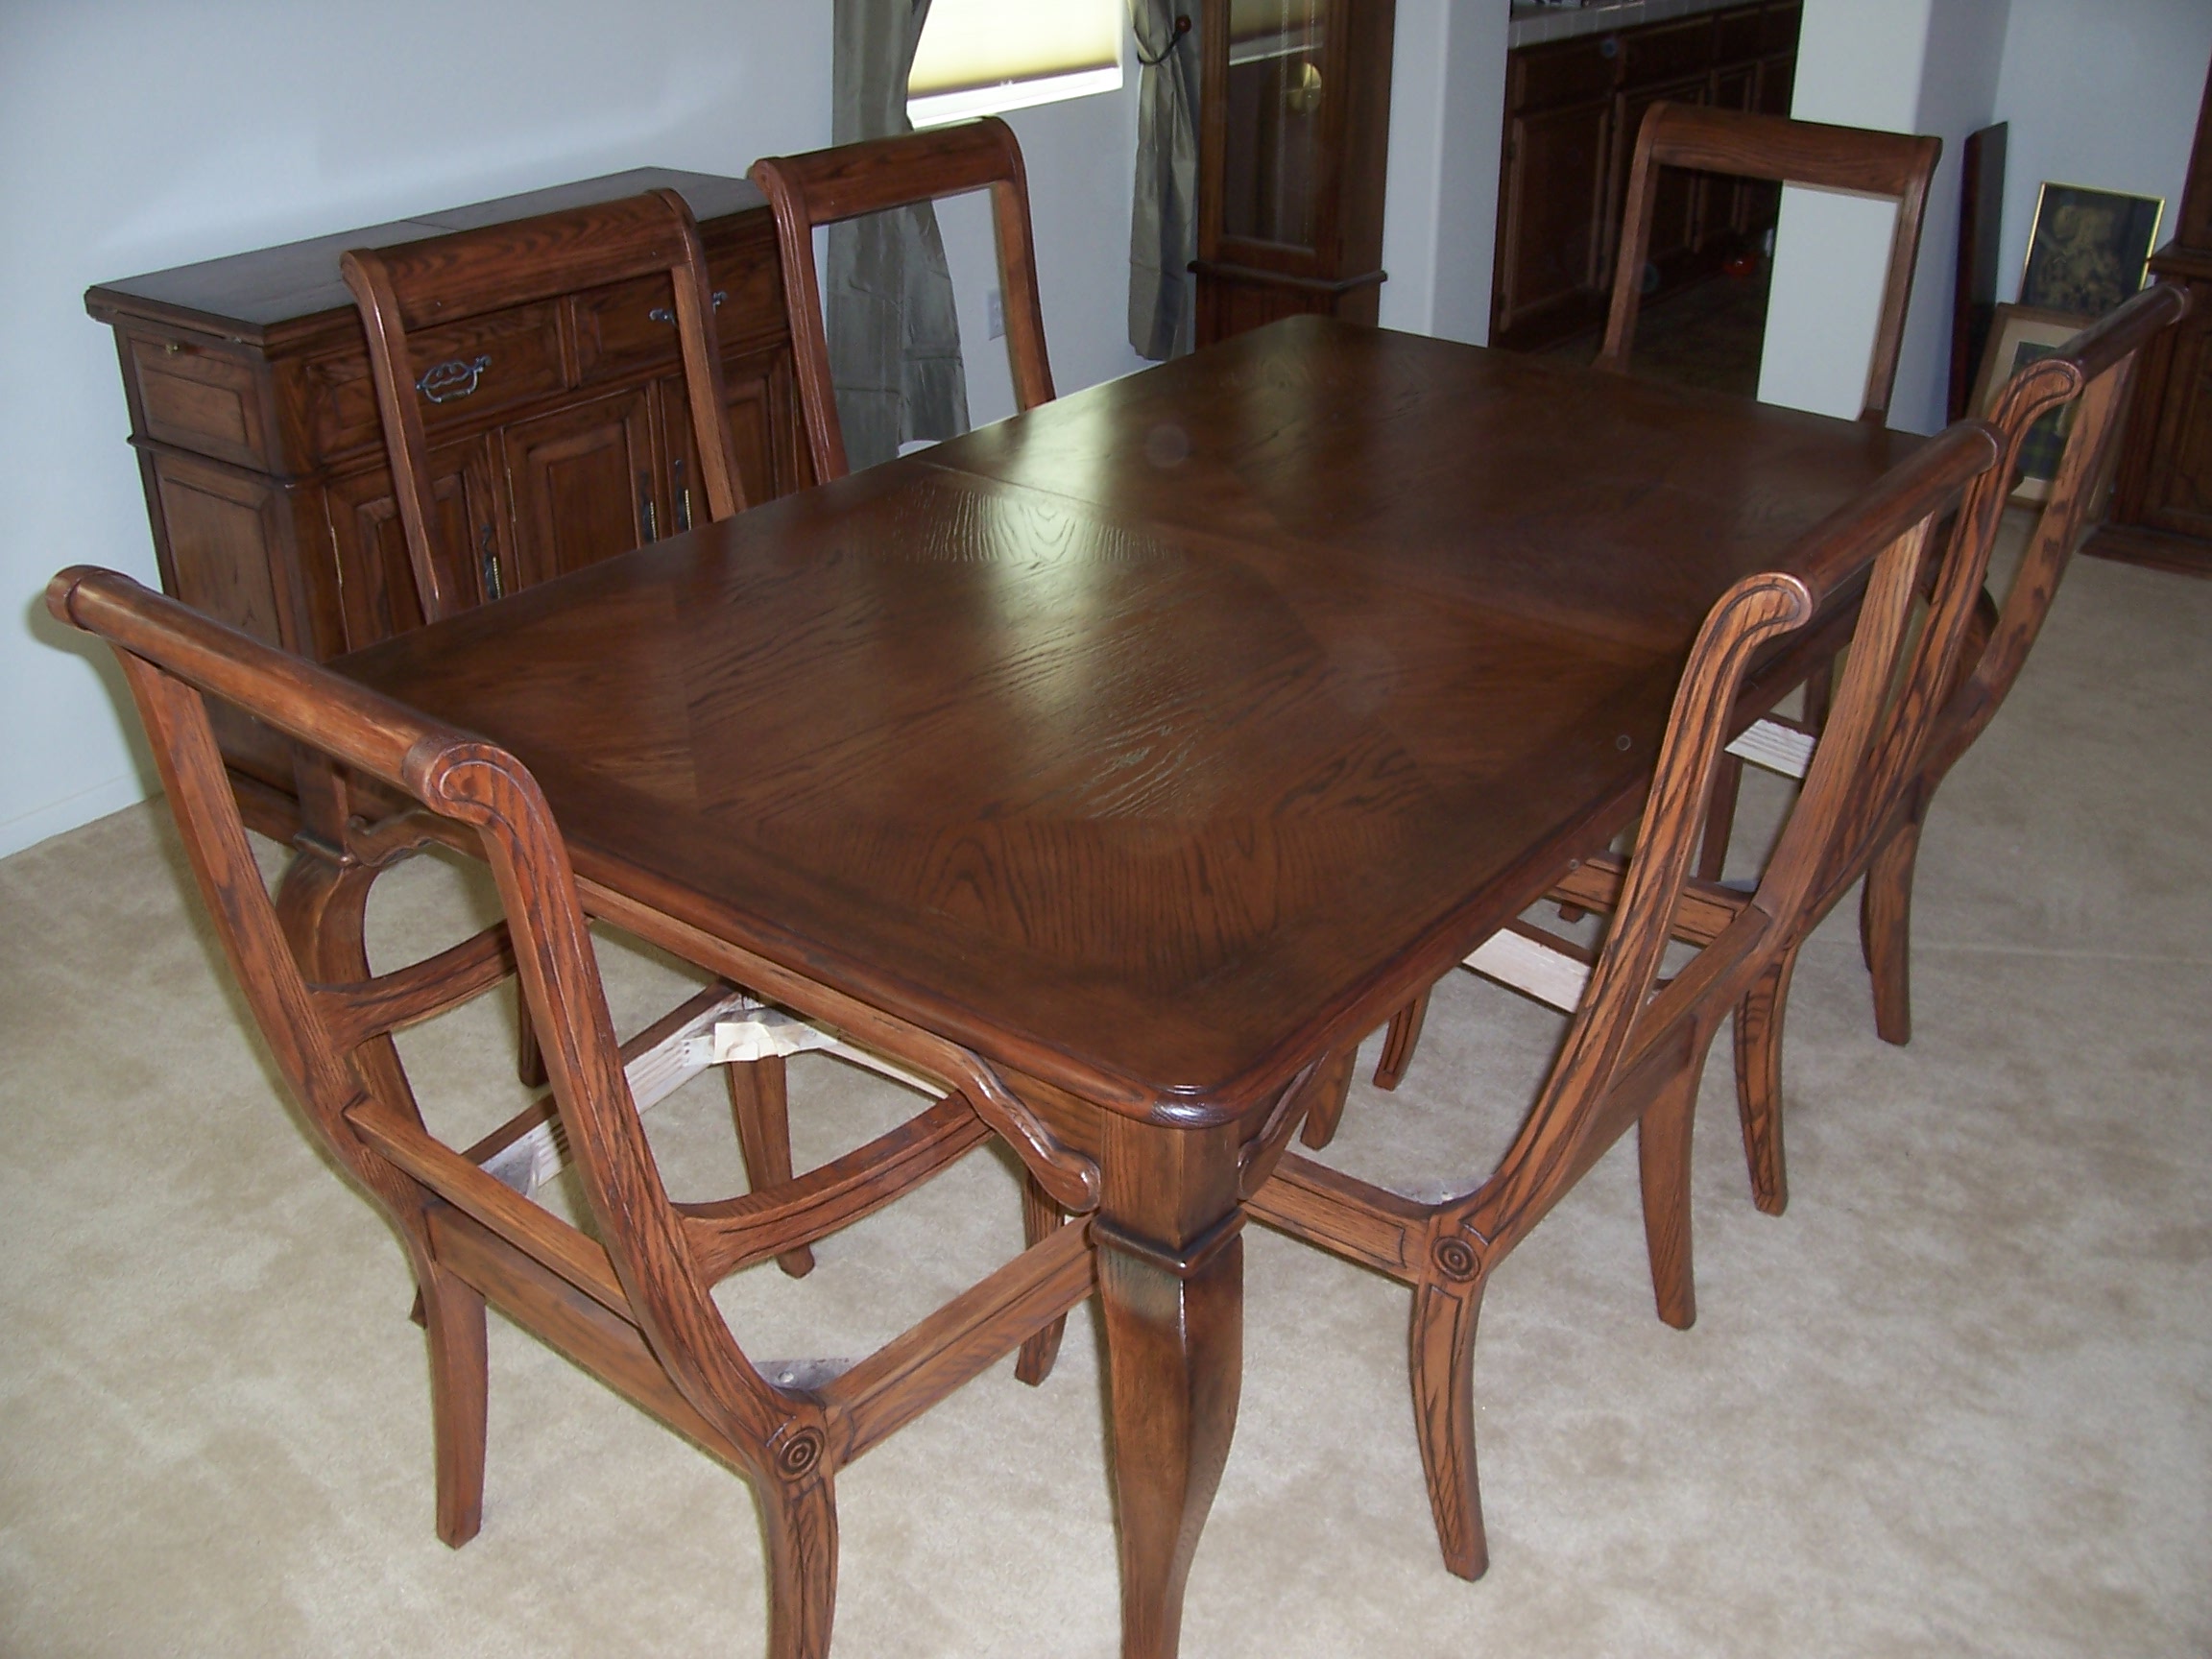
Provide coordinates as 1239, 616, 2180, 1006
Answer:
823, 0, 969, 471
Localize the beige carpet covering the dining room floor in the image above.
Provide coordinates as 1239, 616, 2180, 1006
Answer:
0, 526, 2212, 1659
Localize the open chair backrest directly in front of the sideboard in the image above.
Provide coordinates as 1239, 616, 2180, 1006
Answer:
339, 190, 745, 621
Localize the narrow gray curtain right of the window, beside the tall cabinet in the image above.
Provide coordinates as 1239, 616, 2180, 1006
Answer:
1128, 0, 1199, 363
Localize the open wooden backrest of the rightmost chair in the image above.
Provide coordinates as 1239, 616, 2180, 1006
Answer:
1920, 283, 2190, 787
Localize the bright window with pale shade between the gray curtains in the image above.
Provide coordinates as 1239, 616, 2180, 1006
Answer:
907, 0, 1126, 126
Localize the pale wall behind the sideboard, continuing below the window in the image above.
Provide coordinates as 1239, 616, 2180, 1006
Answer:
0, 0, 1137, 854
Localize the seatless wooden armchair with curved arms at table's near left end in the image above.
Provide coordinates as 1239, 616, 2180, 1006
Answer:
46, 568, 1097, 1659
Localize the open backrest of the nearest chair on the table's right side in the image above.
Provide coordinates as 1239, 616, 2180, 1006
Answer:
1467, 421, 2000, 1252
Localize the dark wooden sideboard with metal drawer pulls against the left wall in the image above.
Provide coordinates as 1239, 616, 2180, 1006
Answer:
84, 168, 812, 809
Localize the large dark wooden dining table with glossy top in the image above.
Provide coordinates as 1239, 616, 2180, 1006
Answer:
339, 316, 1915, 1659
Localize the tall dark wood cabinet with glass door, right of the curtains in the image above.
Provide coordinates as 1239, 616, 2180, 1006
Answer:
1192, 0, 1396, 345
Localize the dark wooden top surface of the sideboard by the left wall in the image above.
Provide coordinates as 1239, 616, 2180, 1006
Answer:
84, 168, 765, 343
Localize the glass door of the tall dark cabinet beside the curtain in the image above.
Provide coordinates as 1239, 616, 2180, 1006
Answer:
1221, 0, 1334, 248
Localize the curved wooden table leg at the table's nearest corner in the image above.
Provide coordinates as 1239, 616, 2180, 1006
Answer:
1093, 1119, 1243, 1659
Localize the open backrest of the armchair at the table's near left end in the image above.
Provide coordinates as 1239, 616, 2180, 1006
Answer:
46, 568, 818, 1462
